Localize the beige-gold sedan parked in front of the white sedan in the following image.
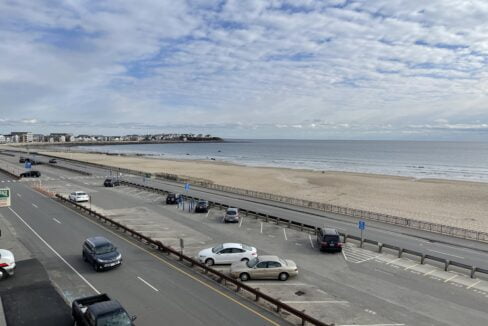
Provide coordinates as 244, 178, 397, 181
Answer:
230, 256, 298, 282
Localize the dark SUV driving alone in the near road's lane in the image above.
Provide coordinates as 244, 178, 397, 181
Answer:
82, 236, 122, 272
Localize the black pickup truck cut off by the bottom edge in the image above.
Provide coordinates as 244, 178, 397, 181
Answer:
71, 293, 136, 326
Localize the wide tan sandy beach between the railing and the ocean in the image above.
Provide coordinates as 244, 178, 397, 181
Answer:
34, 152, 488, 232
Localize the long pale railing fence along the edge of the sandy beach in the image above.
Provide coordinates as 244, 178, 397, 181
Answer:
16, 149, 488, 242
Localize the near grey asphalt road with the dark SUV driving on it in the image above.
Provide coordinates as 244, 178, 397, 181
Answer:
0, 175, 284, 325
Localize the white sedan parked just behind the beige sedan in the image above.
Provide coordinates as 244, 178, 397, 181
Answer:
198, 243, 258, 266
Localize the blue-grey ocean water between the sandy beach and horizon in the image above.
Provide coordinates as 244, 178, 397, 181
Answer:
73, 140, 488, 182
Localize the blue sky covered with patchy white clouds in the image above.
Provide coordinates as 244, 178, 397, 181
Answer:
0, 0, 488, 140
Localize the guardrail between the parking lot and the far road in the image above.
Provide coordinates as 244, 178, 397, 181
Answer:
120, 180, 488, 278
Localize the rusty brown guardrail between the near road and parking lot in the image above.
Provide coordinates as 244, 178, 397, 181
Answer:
56, 194, 334, 326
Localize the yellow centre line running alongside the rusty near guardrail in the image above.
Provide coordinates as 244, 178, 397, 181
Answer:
56, 201, 283, 326
